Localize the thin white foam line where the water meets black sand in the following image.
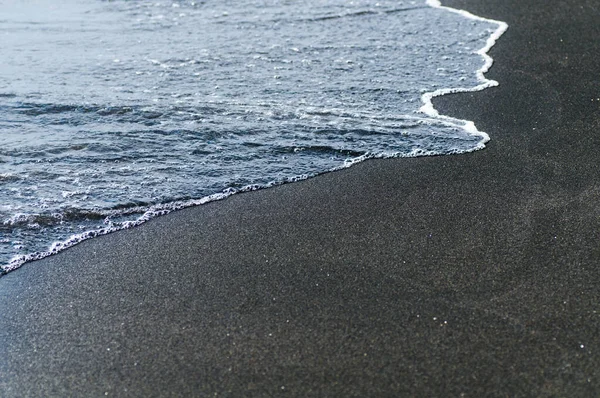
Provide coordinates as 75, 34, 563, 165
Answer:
0, 0, 508, 277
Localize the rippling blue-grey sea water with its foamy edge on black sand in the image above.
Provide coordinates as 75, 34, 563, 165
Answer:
0, 0, 506, 272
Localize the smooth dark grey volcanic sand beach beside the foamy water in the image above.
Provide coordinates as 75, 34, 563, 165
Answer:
0, 0, 600, 397
